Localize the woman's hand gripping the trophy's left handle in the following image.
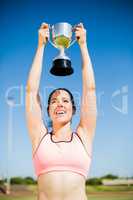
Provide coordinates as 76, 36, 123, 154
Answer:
38, 23, 49, 47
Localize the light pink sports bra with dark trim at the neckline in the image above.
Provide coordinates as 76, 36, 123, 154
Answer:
33, 133, 91, 178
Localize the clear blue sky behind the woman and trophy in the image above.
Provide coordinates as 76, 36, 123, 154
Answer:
0, 0, 133, 178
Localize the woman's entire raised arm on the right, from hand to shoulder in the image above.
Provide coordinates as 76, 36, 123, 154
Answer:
76, 24, 97, 141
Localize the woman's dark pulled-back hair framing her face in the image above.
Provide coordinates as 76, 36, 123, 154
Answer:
47, 88, 76, 115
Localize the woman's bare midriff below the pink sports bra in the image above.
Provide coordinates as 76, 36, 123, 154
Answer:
37, 171, 87, 200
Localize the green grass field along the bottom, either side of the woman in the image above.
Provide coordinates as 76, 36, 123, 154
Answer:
0, 186, 133, 200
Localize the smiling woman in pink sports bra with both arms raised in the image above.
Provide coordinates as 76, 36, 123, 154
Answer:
26, 23, 97, 200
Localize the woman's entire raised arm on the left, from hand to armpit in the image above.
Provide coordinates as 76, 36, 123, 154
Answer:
26, 23, 49, 151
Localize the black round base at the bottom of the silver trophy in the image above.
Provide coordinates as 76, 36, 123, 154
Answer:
50, 59, 73, 76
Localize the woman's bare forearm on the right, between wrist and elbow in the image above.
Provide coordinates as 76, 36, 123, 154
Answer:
80, 43, 95, 90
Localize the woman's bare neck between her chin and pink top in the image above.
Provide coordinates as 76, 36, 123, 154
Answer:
52, 122, 72, 137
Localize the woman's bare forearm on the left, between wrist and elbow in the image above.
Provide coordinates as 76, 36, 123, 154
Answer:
27, 45, 44, 92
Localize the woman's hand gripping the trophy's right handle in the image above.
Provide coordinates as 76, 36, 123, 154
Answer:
74, 23, 86, 46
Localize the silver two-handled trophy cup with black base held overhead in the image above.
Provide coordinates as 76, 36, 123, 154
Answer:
49, 22, 76, 76
